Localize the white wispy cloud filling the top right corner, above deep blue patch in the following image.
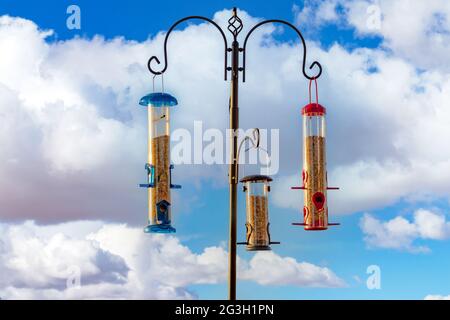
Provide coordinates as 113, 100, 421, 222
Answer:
293, 0, 450, 72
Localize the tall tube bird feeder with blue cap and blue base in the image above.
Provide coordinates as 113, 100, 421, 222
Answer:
139, 92, 181, 233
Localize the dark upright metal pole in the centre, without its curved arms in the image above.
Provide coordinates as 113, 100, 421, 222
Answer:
228, 36, 239, 300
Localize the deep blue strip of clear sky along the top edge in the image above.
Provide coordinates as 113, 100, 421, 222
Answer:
0, 0, 380, 47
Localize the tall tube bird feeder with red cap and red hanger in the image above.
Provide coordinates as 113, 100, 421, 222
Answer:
292, 82, 339, 230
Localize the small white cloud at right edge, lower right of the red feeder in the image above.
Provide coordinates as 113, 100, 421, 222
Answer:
360, 209, 450, 253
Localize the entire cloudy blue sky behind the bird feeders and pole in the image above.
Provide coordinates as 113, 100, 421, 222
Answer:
0, 0, 450, 300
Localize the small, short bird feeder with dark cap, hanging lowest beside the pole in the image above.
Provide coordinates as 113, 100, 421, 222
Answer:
238, 175, 279, 251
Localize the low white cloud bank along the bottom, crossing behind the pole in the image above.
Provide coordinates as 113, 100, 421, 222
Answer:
0, 221, 345, 299
